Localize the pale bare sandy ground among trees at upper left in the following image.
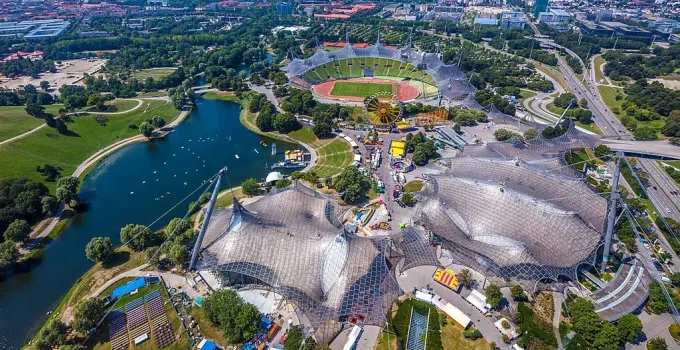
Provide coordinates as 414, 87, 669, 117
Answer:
0, 58, 106, 90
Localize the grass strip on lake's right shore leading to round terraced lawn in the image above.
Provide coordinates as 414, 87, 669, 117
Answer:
209, 92, 354, 177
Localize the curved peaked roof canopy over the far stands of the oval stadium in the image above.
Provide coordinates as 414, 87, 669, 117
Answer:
284, 33, 475, 100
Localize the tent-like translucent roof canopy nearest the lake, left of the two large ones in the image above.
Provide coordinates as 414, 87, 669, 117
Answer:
199, 184, 399, 327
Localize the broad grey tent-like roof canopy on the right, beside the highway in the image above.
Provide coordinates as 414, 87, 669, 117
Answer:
415, 157, 607, 288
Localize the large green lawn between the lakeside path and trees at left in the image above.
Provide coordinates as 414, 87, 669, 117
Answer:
0, 100, 179, 190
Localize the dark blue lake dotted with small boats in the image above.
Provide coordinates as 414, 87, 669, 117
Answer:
0, 99, 297, 349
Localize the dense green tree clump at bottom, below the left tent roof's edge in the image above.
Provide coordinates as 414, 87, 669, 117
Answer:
203, 290, 260, 343
